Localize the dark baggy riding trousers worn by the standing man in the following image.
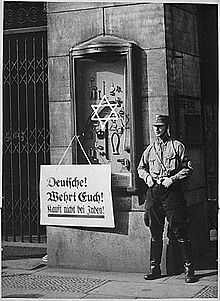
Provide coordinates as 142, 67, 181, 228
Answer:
144, 183, 188, 242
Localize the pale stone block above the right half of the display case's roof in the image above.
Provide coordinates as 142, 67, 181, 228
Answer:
105, 4, 165, 48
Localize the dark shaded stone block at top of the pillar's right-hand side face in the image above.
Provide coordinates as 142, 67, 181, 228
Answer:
165, 5, 199, 54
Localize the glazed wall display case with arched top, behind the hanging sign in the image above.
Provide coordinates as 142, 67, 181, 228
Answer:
70, 36, 141, 191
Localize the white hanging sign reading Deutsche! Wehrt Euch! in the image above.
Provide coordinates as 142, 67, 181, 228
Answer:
40, 164, 115, 228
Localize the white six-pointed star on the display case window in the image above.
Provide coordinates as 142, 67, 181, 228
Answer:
91, 95, 119, 130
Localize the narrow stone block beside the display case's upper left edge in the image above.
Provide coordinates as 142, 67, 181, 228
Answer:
48, 56, 70, 101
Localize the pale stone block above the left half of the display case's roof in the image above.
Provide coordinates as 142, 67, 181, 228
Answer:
48, 9, 103, 57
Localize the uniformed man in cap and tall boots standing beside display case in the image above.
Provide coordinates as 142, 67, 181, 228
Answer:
138, 115, 195, 283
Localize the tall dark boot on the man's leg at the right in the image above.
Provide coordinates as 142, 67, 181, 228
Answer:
179, 240, 196, 283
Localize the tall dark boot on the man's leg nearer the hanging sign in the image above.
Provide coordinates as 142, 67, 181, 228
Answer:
144, 240, 163, 280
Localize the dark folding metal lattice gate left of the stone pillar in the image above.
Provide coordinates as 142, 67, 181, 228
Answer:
3, 32, 49, 242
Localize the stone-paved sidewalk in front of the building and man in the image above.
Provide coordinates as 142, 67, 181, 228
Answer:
2, 252, 218, 300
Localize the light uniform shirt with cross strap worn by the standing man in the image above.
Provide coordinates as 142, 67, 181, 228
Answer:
138, 136, 192, 182
